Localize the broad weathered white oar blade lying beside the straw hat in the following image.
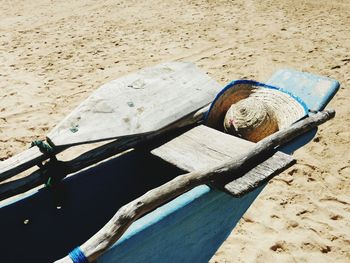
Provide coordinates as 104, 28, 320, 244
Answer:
47, 62, 220, 146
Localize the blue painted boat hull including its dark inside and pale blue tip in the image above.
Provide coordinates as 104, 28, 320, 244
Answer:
0, 70, 339, 263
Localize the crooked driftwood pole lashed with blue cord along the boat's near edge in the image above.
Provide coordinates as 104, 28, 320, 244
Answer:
56, 110, 335, 263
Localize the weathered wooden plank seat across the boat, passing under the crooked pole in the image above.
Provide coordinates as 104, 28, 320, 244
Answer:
152, 125, 294, 196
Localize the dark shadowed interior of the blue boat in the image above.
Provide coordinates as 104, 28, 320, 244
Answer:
0, 151, 182, 262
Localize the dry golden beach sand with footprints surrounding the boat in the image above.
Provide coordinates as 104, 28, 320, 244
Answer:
0, 0, 350, 262
